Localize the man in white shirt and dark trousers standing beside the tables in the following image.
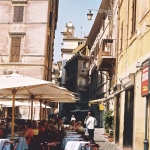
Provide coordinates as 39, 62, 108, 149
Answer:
86, 112, 96, 142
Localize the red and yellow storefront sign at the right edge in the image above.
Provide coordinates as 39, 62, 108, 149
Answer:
141, 59, 150, 96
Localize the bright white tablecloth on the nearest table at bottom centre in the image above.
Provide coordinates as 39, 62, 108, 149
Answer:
65, 141, 90, 150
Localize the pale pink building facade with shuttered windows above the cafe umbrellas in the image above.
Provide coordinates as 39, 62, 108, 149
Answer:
0, 0, 58, 81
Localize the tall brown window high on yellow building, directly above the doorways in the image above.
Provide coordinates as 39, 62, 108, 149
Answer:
131, 0, 136, 34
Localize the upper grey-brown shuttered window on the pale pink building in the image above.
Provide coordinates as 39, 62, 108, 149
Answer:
14, 6, 24, 22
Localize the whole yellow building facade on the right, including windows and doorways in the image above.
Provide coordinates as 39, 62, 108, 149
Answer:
116, 0, 150, 150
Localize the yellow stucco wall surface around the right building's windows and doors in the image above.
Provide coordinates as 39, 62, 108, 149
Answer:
118, 0, 150, 150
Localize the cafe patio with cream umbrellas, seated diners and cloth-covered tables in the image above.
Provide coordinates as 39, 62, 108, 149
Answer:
0, 73, 120, 150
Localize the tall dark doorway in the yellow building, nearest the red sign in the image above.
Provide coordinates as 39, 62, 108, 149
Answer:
123, 88, 134, 149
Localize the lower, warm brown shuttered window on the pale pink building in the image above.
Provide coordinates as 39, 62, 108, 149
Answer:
10, 37, 21, 62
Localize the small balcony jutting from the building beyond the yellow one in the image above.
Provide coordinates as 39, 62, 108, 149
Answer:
97, 39, 116, 74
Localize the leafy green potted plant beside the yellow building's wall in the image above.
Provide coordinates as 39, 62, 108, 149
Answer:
104, 110, 114, 136
